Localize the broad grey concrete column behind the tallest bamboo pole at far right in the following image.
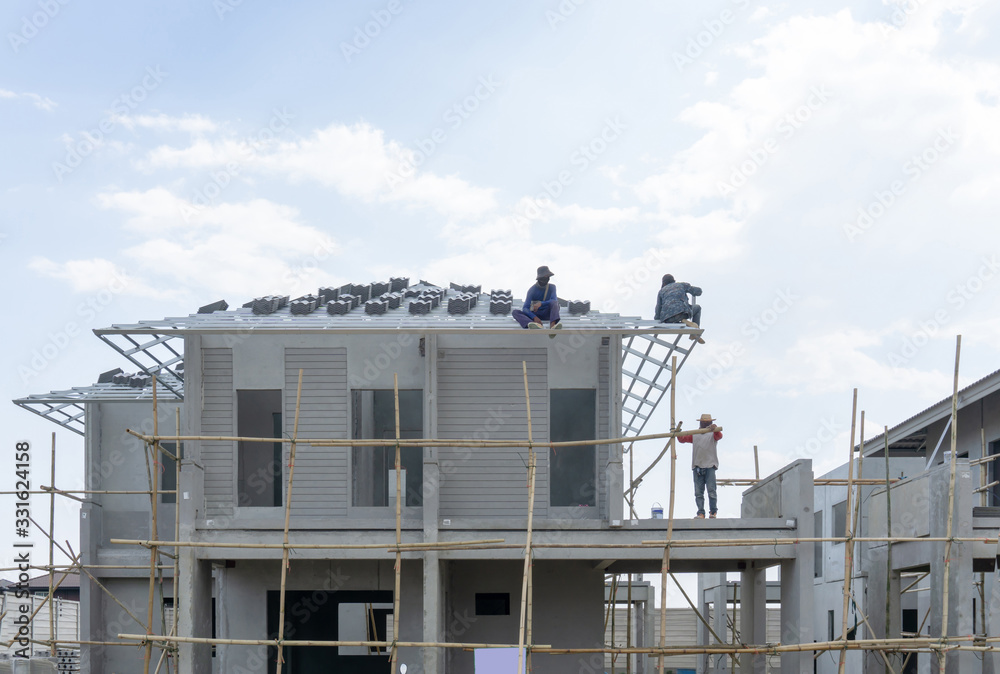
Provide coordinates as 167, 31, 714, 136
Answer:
929, 459, 979, 674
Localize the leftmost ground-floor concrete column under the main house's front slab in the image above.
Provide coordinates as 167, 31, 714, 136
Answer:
174, 548, 212, 674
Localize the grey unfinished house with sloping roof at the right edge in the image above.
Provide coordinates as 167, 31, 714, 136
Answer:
814, 371, 1000, 674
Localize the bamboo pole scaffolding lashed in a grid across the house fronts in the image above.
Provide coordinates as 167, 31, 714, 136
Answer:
17, 350, 1000, 673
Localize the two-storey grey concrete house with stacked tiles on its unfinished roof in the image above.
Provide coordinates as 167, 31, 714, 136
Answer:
15, 279, 813, 674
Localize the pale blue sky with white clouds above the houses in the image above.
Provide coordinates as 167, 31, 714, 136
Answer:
0, 0, 1000, 608
